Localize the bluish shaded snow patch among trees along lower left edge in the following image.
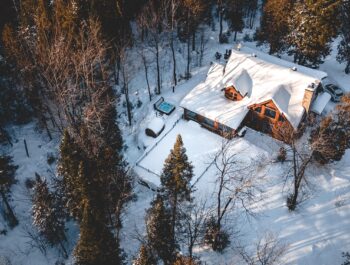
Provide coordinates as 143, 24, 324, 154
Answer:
0, 122, 77, 265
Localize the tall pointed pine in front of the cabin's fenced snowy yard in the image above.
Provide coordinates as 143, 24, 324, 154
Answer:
160, 135, 193, 256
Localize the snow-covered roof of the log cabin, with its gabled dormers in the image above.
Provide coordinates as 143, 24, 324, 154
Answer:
181, 47, 327, 129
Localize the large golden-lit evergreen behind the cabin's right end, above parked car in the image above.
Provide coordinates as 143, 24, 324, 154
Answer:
287, 0, 339, 67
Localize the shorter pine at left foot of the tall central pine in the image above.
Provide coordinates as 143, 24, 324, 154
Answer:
146, 195, 177, 265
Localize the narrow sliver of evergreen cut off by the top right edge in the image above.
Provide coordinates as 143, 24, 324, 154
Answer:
337, 0, 350, 74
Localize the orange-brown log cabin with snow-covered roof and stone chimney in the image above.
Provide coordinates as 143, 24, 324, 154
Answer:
180, 46, 327, 142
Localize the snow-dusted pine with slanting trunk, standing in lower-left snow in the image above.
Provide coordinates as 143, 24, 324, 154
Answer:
32, 175, 68, 257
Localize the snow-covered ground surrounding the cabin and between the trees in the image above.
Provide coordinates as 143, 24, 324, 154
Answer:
0, 8, 350, 265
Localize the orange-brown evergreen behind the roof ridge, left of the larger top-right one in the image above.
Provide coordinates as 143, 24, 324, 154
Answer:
256, 0, 294, 54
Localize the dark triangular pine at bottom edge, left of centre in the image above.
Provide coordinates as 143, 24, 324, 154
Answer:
74, 198, 123, 265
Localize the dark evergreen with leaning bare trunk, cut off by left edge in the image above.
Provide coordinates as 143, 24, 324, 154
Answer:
0, 156, 18, 228
